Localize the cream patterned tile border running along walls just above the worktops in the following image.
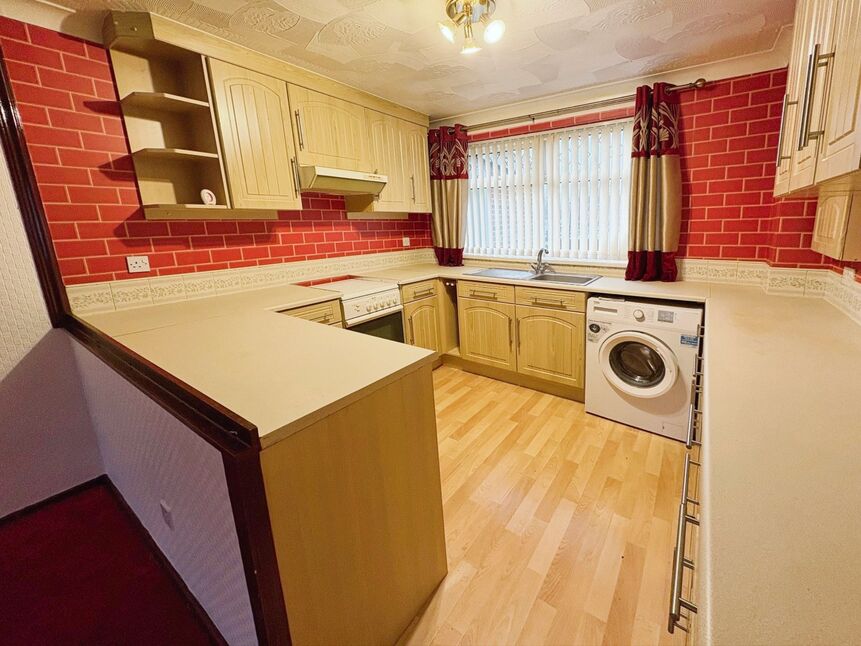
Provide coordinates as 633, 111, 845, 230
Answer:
66, 249, 861, 324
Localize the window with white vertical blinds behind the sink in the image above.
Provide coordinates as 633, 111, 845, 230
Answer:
465, 119, 633, 262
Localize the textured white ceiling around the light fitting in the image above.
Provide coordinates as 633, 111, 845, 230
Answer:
54, 0, 795, 118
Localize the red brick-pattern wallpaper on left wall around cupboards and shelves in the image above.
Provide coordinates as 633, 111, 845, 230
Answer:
0, 16, 431, 284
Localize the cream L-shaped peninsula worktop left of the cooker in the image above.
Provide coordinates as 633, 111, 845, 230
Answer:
82, 285, 435, 448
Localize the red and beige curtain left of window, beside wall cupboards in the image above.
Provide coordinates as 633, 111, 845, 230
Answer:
428, 125, 469, 267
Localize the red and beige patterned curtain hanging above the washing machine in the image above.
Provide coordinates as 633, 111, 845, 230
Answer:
625, 83, 682, 282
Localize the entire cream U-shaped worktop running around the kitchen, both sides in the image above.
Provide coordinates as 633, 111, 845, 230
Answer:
82, 264, 861, 644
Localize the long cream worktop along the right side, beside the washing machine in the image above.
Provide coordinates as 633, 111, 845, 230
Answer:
697, 286, 861, 646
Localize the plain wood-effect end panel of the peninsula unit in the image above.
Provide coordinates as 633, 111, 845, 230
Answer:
260, 365, 447, 646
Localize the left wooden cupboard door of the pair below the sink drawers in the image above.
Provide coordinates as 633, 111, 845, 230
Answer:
458, 298, 517, 370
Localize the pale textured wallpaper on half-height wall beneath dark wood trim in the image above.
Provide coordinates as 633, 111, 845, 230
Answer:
75, 344, 257, 646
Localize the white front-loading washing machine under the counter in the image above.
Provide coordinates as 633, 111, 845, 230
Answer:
586, 296, 703, 441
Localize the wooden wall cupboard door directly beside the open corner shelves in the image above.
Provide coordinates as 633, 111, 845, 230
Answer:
209, 59, 302, 209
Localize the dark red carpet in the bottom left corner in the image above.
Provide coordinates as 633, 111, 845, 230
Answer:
0, 485, 212, 646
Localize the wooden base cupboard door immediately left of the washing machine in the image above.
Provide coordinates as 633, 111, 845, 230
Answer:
517, 305, 586, 388
